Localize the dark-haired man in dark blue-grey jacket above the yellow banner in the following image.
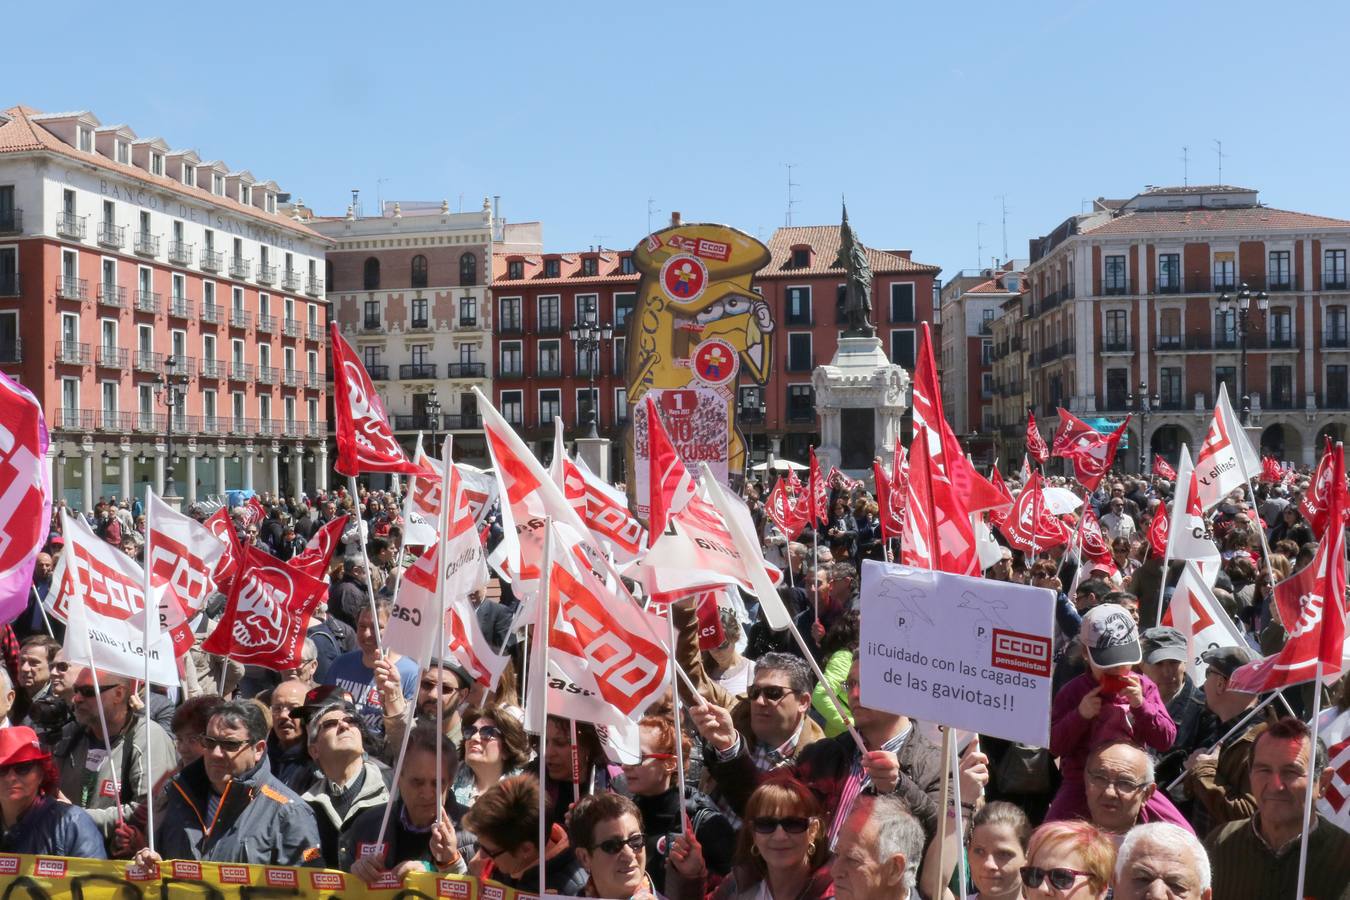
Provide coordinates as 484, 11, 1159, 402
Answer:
136, 700, 323, 866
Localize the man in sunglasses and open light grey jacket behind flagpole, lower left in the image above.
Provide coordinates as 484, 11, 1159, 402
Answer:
53, 669, 178, 841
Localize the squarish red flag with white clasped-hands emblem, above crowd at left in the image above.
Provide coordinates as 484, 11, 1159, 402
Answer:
201, 546, 328, 672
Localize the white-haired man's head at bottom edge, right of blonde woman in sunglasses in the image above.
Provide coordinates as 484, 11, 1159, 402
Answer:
1111, 822, 1214, 900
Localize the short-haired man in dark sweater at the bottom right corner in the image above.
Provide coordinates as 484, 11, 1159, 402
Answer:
1206, 716, 1350, 900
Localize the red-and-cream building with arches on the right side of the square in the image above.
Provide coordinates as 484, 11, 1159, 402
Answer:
1000, 186, 1350, 466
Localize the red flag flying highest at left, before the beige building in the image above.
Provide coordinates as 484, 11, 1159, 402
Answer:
328, 322, 421, 477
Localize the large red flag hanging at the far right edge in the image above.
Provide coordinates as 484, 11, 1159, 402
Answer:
1229, 444, 1346, 694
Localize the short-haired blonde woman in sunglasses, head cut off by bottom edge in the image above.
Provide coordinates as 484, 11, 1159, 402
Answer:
1021, 819, 1115, 900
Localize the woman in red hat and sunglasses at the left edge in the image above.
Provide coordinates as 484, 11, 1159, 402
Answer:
0, 725, 108, 860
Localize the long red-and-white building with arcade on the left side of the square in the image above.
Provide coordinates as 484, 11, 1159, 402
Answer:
0, 107, 328, 509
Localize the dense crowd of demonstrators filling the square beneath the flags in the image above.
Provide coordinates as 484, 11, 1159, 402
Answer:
0, 464, 1350, 900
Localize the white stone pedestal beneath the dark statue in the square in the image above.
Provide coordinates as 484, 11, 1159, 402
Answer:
811, 337, 910, 480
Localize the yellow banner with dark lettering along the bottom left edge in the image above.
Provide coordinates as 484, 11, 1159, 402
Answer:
0, 854, 548, 900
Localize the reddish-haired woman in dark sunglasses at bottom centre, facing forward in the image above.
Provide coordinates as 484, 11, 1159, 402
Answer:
713, 773, 834, 900
